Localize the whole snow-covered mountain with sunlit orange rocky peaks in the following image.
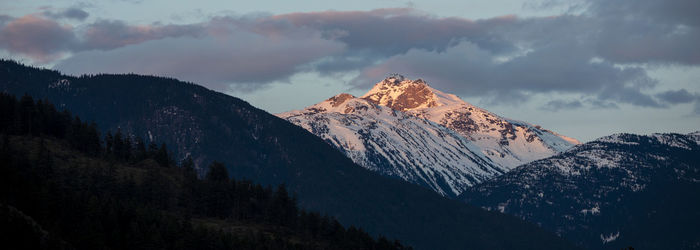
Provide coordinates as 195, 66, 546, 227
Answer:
278, 75, 579, 197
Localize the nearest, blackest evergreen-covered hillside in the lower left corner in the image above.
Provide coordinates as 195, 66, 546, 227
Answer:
0, 94, 407, 249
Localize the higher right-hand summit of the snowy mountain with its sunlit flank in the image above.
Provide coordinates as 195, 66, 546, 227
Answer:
362, 75, 580, 168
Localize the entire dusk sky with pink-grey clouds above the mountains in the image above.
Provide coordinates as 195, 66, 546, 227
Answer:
0, 0, 700, 141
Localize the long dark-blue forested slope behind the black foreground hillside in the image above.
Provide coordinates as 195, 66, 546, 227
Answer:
0, 61, 571, 249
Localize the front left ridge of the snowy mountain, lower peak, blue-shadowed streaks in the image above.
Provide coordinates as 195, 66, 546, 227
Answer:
278, 94, 505, 197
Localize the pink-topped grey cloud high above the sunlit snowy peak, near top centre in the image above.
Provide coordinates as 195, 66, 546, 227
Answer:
256, 9, 515, 55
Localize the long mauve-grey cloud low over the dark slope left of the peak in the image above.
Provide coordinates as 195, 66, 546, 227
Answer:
55, 32, 344, 91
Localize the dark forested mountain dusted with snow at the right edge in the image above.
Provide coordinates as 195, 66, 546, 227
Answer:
459, 132, 700, 249
